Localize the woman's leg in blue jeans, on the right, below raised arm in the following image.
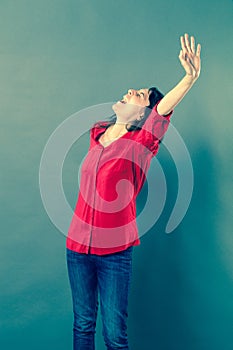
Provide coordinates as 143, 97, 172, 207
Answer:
97, 247, 133, 350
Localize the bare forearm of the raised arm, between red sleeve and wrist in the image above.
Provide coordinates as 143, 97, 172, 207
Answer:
157, 74, 197, 115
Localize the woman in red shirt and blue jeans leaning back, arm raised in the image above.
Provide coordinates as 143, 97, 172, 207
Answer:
66, 34, 201, 350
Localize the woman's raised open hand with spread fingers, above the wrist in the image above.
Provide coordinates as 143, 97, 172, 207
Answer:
179, 33, 201, 81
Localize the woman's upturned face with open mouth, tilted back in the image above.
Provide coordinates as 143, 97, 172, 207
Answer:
112, 89, 150, 122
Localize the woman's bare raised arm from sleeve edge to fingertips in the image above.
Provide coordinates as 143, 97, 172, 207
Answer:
157, 33, 201, 115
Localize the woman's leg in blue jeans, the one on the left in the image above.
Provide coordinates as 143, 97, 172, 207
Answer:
66, 249, 98, 350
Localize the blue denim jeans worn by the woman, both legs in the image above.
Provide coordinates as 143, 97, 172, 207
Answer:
66, 246, 133, 350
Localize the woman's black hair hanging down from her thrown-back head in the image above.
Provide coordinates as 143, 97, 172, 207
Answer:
95, 87, 164, 131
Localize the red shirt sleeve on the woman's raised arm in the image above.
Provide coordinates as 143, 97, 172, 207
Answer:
142, 100, 174, 156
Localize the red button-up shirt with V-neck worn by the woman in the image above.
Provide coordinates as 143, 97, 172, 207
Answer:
66, 102, 173, 255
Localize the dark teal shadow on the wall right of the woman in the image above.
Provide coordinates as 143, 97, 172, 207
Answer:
128, 138, 233, 350
